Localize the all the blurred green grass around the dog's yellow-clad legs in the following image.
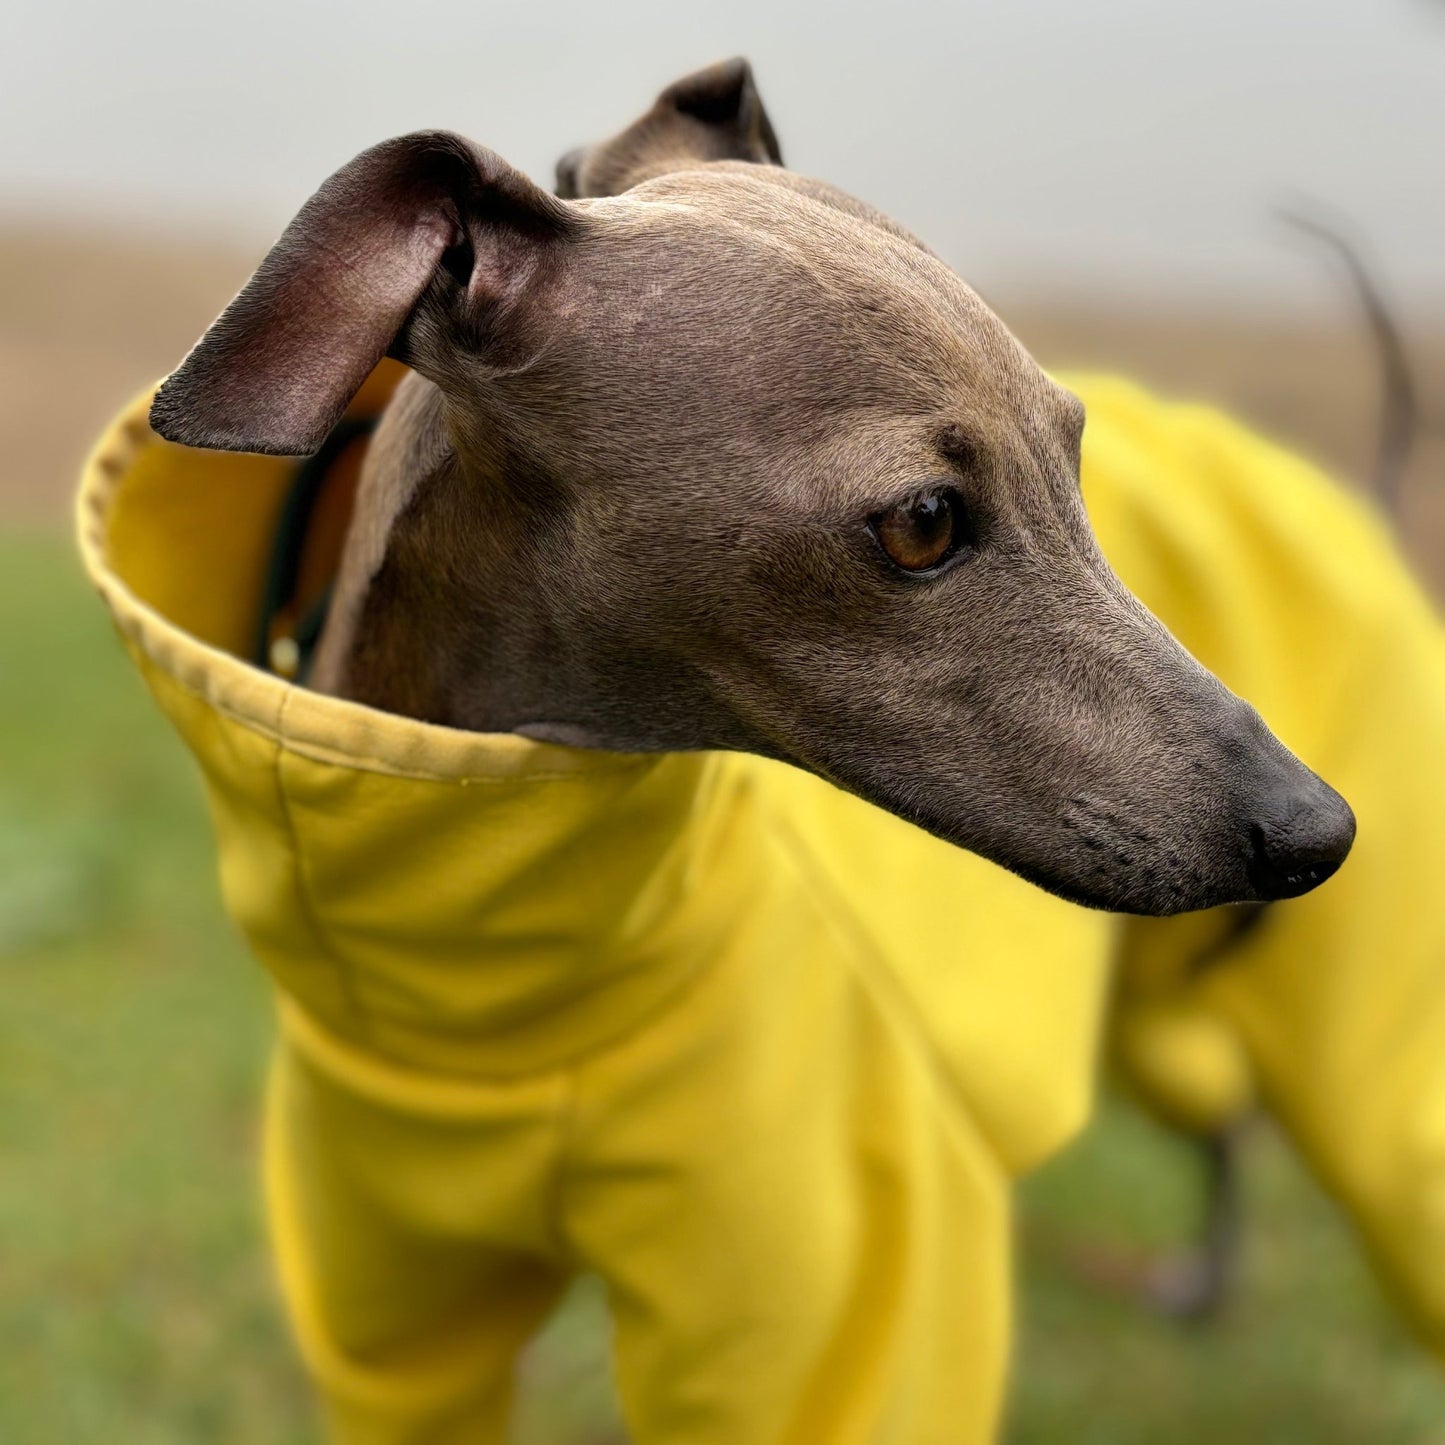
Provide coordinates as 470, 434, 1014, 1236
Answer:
0, 535, 1445, 1445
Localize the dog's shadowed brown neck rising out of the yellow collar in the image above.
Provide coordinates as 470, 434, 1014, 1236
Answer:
312, 374, 767, 751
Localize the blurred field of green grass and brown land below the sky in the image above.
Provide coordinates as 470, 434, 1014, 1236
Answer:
0, 222, 1445, 1445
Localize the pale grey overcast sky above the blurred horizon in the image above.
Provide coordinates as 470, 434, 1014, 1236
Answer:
8, 0, 1445, 309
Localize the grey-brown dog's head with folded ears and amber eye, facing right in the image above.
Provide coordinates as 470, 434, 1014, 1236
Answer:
153, 65, 1354, 912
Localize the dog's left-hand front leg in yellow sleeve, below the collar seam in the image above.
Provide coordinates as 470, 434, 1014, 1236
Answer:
266, 1042, 566, 1445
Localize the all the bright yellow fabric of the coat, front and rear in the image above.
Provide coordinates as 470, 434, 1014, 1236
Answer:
79, 379, 1445, 1445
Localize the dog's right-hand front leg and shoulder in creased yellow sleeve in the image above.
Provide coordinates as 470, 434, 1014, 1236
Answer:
564, 867, 1010, 1445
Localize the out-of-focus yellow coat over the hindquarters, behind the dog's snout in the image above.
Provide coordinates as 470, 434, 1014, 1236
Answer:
1085, 383, 1445, 1358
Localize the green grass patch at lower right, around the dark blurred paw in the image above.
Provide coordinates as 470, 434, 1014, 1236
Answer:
1009, 1104, 1445, 1445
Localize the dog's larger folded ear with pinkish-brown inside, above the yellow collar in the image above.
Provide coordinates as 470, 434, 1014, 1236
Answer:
150, 131, 582, 455
